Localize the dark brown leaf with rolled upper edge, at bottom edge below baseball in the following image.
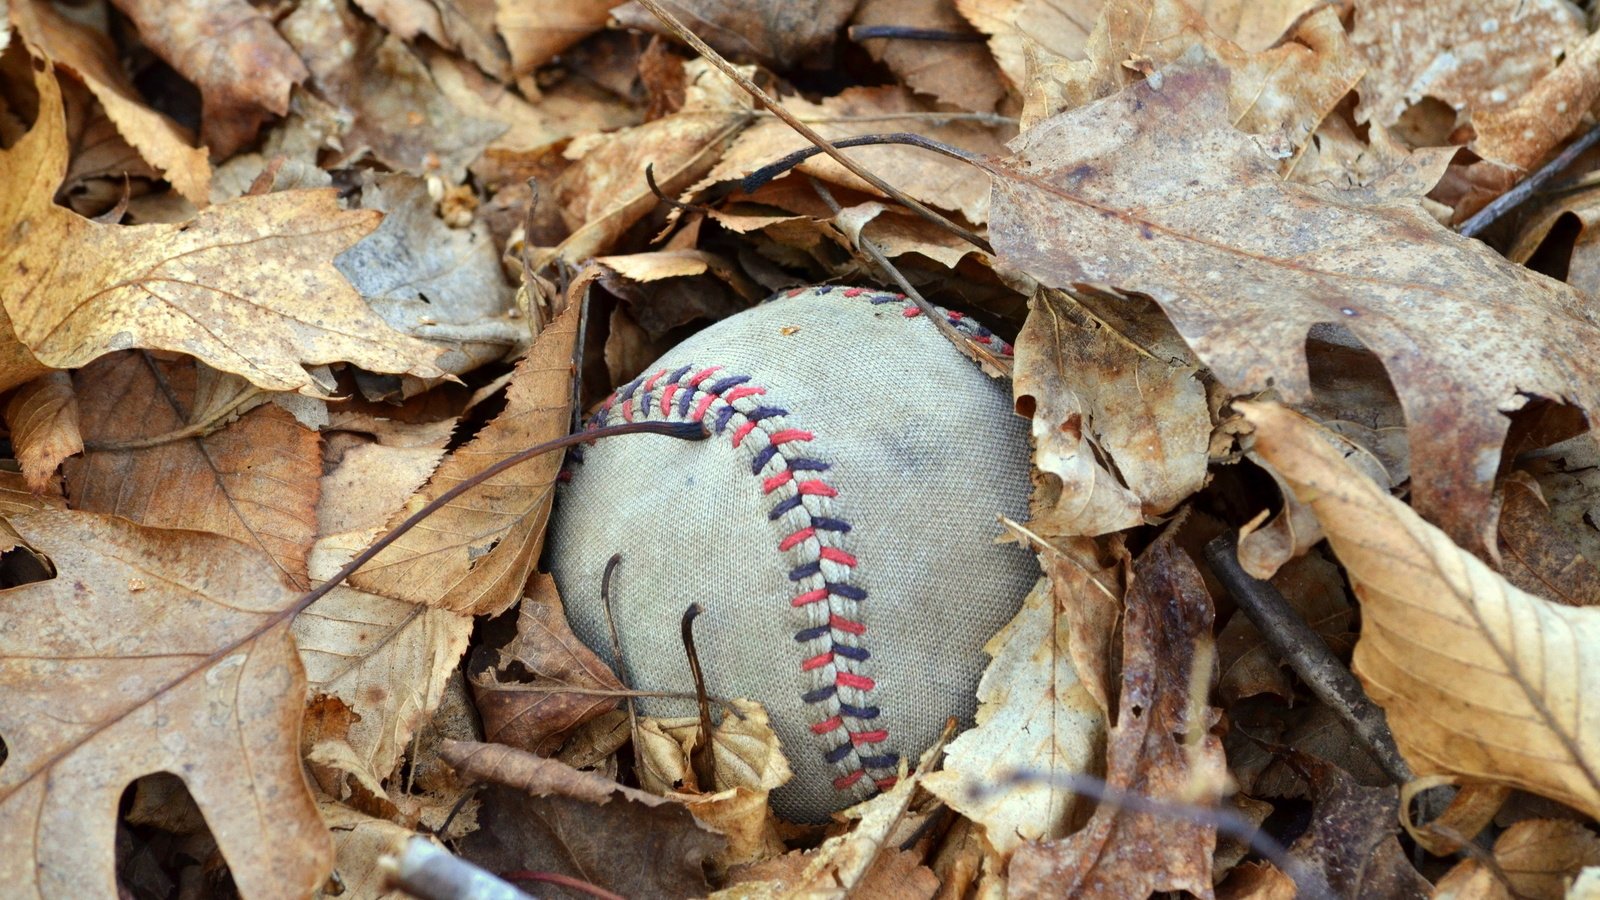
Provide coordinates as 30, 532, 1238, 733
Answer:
442, 741, 723, 897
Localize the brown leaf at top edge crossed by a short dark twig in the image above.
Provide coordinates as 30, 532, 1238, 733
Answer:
851, 0, 1006, 112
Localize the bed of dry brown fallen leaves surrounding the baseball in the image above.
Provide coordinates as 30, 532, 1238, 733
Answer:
0, 0, 1600, 900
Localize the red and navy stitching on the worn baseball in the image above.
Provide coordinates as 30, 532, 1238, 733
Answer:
573, 287, 1011, 796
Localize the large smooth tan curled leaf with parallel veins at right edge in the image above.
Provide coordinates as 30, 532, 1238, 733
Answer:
1240, 404, 1600, 815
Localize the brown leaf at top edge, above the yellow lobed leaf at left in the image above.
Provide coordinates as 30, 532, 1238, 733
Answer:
114, 0, 309, 159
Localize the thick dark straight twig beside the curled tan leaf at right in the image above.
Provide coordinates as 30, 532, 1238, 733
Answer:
1205, 532, 1414, 785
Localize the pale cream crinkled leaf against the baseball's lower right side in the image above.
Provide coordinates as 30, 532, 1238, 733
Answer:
922, 580, 1106, 860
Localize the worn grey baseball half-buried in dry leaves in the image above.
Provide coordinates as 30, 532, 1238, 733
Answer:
547, 287, 1038, 822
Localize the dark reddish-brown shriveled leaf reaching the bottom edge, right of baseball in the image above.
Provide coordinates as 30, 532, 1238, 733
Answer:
1006, 533, 1226, 897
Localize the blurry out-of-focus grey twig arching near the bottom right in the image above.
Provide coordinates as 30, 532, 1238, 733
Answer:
992, 770, 1334, 900
